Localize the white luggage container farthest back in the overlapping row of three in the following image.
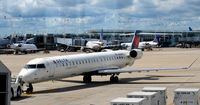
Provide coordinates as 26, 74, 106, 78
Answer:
142, 87, 167, 105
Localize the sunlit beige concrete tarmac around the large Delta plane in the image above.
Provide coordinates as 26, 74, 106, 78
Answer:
0, 48, 200, 105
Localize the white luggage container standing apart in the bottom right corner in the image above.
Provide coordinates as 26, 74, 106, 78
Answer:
174, 88, 200, 105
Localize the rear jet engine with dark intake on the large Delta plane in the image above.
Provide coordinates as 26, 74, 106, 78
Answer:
129, 49, 143, 59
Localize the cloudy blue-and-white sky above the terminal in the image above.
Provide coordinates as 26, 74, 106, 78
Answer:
0, 0, 200, 35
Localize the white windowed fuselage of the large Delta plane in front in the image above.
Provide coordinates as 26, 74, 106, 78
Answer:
19, 50, 134, 83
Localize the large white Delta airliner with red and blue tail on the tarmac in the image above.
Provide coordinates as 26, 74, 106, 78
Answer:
18, 33, 195, 93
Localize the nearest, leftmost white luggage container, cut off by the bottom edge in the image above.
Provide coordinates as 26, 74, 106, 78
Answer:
110, 97, 149, 105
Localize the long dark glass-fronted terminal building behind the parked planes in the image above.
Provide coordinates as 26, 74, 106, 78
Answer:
2, 29, 200, 49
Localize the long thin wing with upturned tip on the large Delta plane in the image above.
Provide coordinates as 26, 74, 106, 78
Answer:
98, 58, 198, 74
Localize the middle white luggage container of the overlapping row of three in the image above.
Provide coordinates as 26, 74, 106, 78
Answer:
127, 91, 159, 105
